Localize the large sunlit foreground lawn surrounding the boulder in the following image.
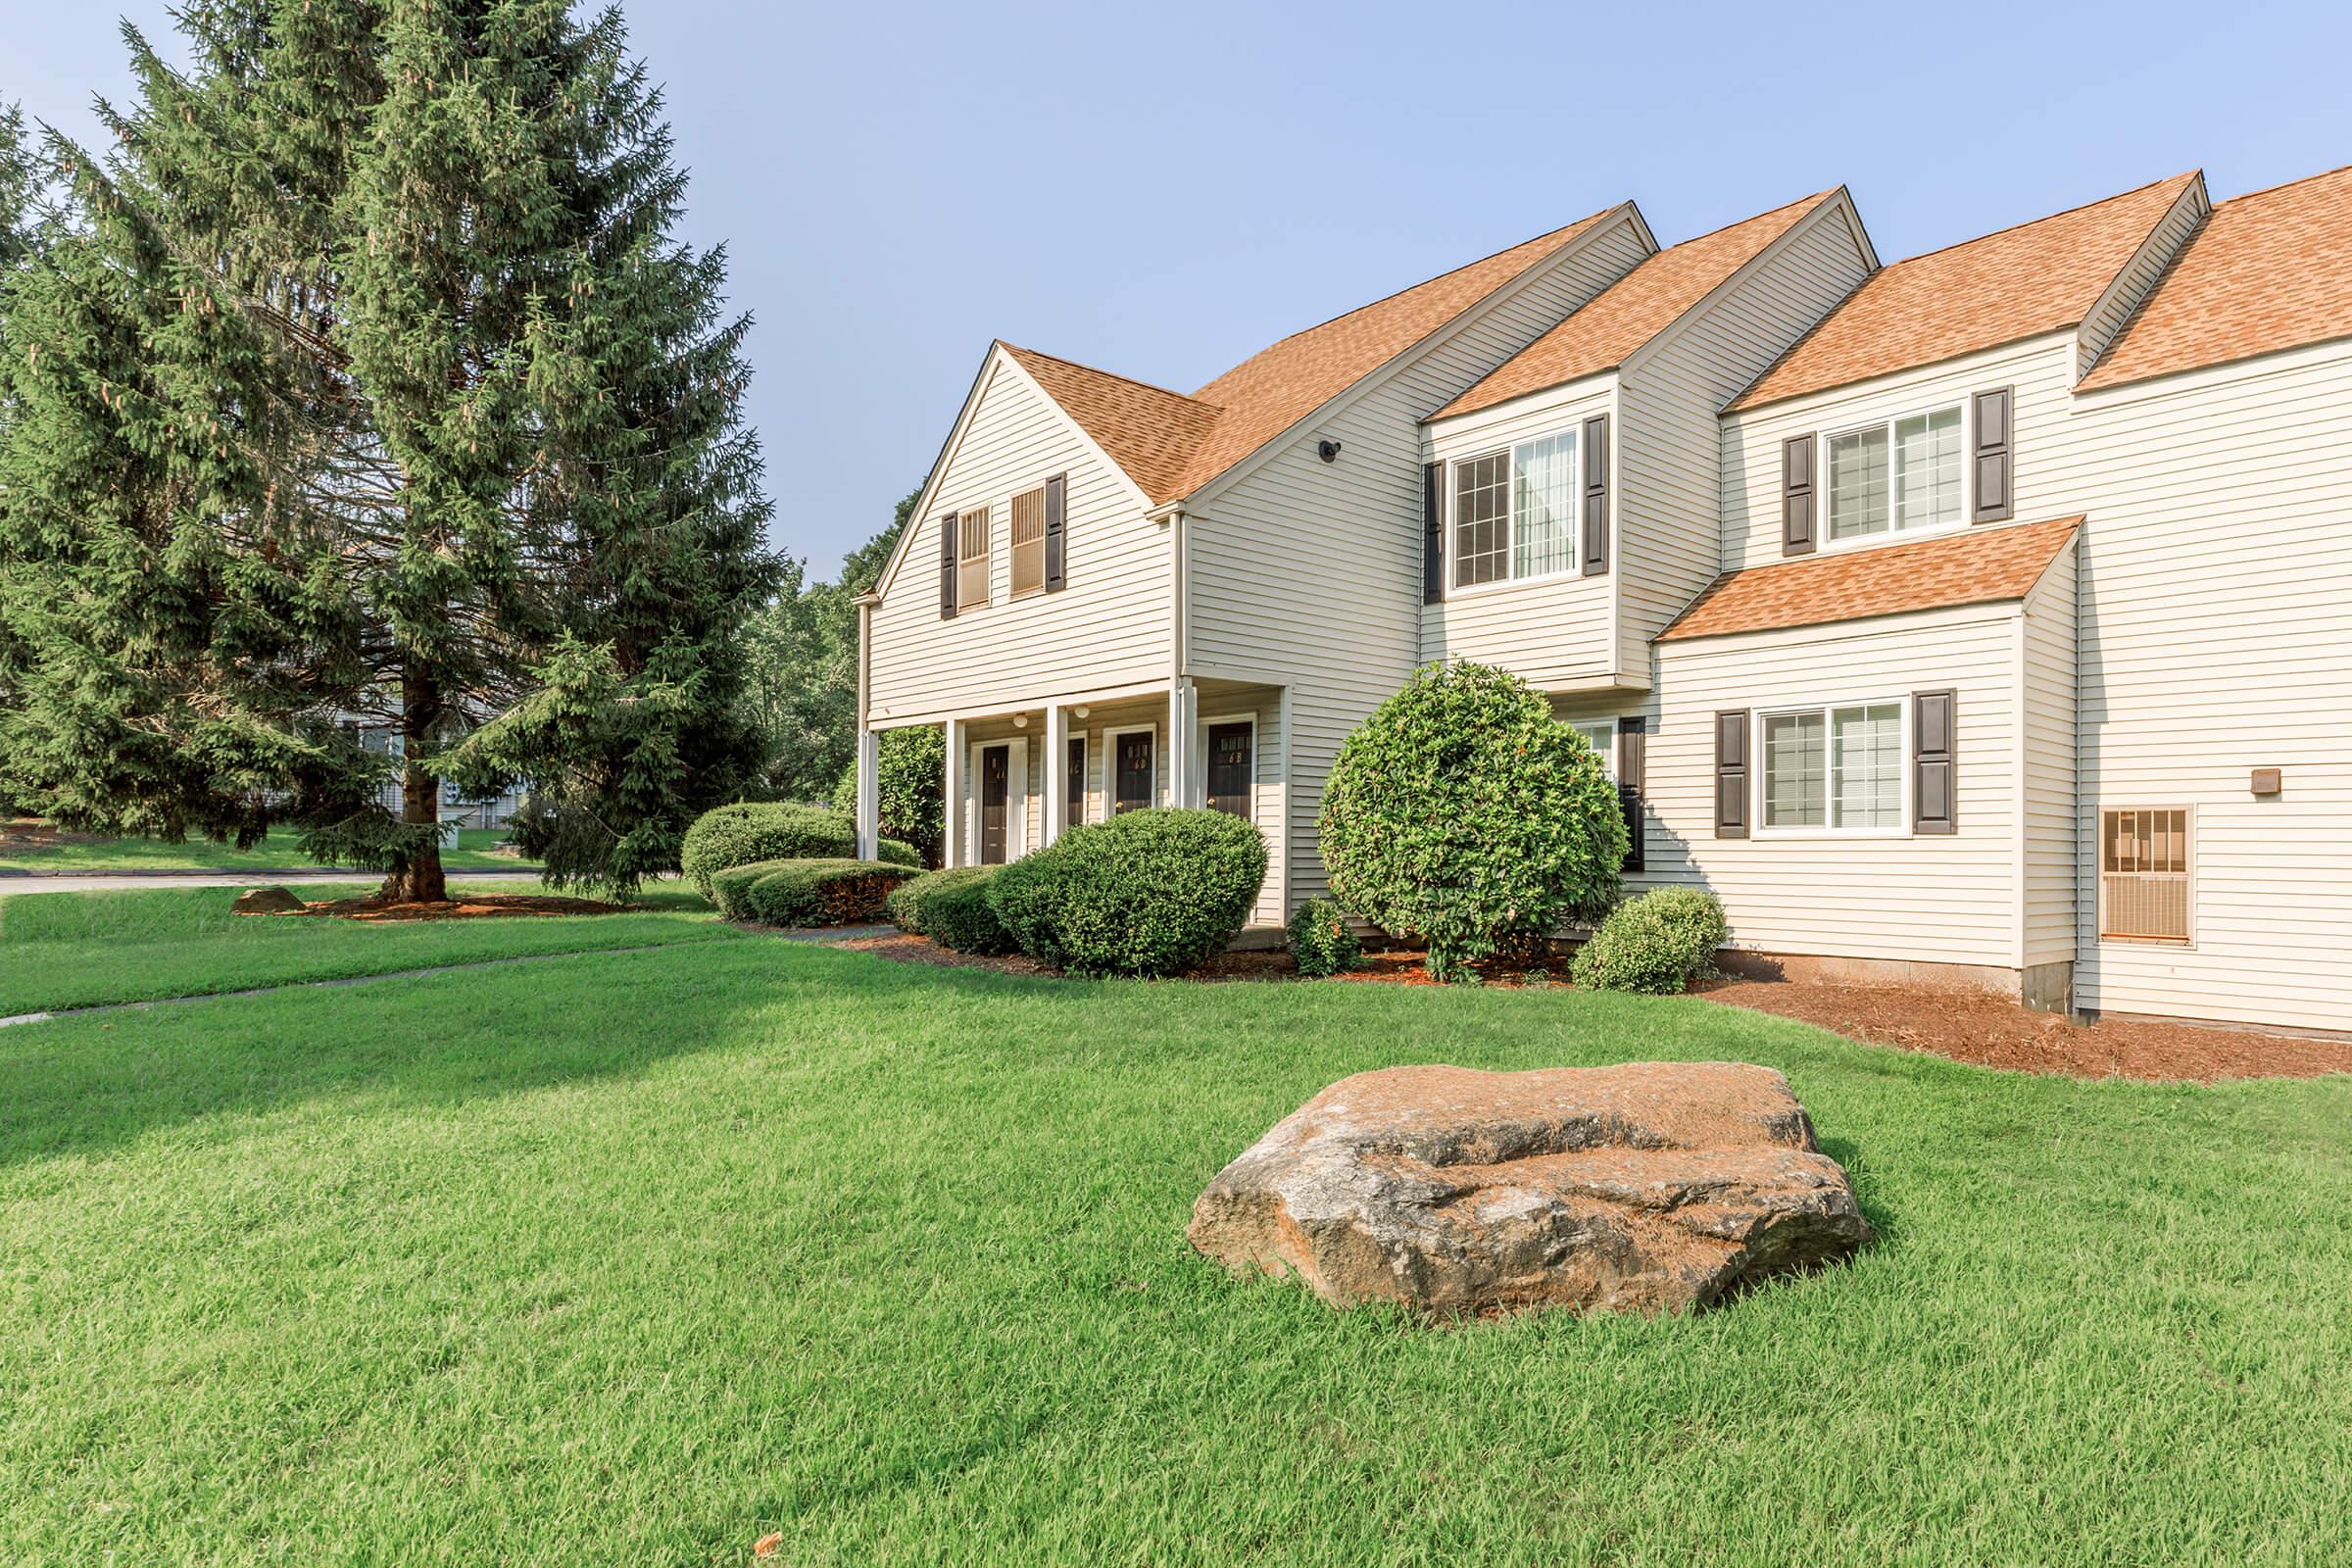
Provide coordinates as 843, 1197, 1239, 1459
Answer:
0, 938, 2352, 1568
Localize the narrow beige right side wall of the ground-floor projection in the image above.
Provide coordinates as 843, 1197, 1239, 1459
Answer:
2018, 550, 2077, 966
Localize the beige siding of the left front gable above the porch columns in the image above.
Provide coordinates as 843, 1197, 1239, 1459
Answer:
872, 353, 1174, 724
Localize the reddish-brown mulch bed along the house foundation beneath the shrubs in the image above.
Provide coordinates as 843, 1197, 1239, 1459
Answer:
840, 933, 2352, 1084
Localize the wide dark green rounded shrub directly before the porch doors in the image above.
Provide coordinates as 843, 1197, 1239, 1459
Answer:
988, 807, 1265, 976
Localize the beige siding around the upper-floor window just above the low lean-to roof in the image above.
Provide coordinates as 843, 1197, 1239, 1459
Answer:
1717, 331, 2083, 571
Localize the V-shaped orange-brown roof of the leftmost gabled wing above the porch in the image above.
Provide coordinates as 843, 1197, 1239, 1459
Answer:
1004, 207, 1625, 506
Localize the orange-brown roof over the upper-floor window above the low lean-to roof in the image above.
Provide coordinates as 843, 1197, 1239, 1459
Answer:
1731, 170, 2197, 409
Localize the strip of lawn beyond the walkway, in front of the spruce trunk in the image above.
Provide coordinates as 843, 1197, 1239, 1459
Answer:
0, 879, 743, 1018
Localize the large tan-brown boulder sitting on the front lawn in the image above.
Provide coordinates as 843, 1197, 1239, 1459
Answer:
1190, 1062, 1870, 1316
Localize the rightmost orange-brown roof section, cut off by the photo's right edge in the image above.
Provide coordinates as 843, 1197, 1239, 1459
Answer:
2082, 167, 2352, 390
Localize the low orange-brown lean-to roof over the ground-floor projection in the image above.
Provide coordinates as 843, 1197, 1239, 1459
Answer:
1658, 517, 2082, 642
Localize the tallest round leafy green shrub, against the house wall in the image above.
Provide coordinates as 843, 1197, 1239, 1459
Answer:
1317, 662, 1625, 980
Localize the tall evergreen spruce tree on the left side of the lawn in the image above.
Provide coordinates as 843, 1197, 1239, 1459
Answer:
0, 0, 776, 898
